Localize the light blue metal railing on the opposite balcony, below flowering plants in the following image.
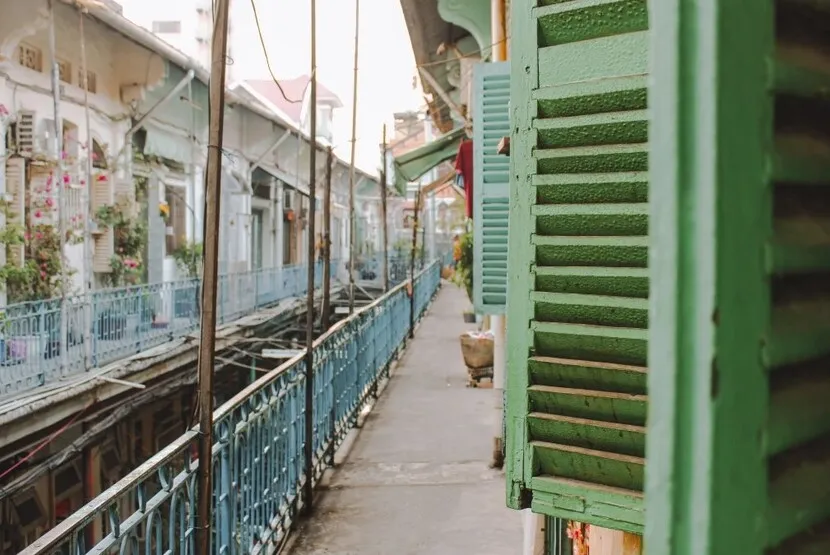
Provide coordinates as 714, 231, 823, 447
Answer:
0, 262, 337, 396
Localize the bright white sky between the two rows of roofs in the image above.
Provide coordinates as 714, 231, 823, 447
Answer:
231, 0, 423, 173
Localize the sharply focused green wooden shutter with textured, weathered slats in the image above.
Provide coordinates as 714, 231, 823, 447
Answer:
507, 0, 649, 533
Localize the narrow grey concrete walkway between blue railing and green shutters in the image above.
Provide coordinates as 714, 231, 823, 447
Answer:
291, 285, 522, 555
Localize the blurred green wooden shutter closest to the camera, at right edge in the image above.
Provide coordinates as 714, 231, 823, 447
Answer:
645, 0, 830, 555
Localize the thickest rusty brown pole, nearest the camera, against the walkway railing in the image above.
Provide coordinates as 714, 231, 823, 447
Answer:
196, 0, 230, 555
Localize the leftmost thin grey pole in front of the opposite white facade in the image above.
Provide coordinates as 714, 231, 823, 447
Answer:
49, 0, 68, 375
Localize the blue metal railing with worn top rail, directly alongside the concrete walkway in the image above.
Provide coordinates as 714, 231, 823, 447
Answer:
21, 261, 441, 555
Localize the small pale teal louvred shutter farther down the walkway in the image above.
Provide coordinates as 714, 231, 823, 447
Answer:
473, 62, 510, 314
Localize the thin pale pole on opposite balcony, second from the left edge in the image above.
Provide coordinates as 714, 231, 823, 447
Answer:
78, 8, 95, 368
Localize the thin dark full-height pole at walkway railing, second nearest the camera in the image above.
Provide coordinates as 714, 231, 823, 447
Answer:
303, 0, 317, 516
